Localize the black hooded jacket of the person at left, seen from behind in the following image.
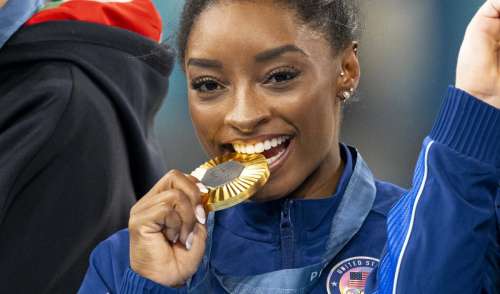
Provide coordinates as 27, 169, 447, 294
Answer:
0, 21, 173, 293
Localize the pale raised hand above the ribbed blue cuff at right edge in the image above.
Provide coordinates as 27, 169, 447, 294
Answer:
455, 0, 500, 108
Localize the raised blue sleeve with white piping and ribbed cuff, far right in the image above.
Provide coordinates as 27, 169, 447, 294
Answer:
366, 87, 500, 294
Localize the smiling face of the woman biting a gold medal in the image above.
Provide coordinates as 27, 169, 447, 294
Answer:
184, 1, 359, 201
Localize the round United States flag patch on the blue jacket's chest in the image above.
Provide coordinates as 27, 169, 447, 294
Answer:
326, 256, 379, 294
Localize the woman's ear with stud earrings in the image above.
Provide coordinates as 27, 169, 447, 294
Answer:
337, 42, 361, 99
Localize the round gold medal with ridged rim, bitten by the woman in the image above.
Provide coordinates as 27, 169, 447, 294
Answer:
191, 153, 270, 211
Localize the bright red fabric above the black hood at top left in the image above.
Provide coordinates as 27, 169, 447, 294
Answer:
26, 0, 162, 42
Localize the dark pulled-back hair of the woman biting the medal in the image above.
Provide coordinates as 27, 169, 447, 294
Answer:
178, 0, 361, 62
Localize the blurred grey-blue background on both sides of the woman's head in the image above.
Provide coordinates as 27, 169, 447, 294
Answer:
155, 0, 483, 187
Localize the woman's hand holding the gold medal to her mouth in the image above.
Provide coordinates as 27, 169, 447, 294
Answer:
129, 170, 208, 287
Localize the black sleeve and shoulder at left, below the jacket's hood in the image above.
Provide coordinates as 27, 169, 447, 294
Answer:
0, 62, 135, 293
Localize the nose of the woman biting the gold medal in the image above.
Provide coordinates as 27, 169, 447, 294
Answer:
224, 94, 271, 133
